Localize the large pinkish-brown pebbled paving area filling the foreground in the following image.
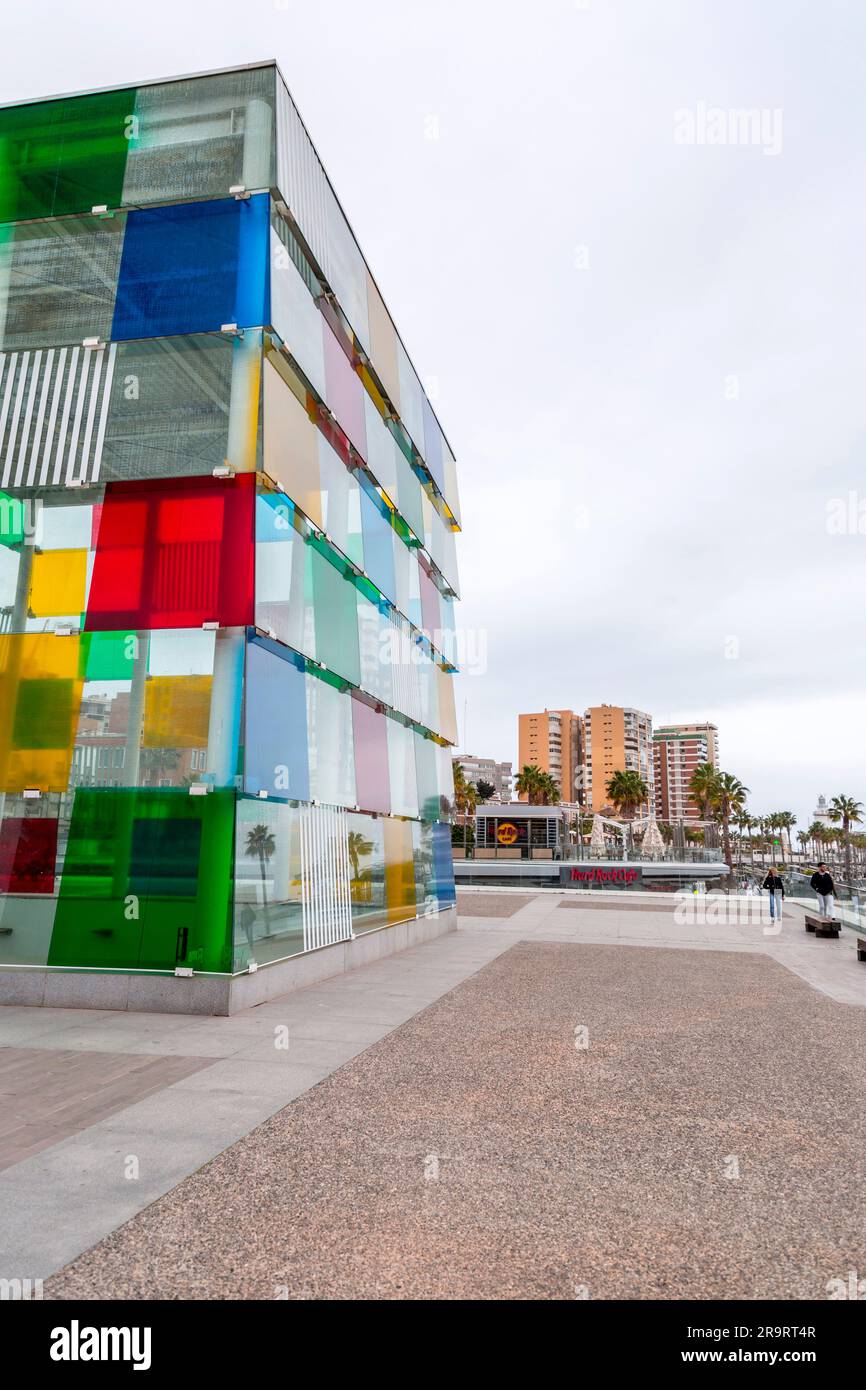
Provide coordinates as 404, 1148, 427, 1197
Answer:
46, 940, 866, 1300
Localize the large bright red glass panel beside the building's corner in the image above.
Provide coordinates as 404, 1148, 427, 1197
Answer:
85, 474, 256, 631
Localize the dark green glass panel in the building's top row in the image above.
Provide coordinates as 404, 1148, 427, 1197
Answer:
0, 89, 135, 222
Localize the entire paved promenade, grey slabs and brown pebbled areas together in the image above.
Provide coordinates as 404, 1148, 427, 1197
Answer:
0, 892, 866, 1298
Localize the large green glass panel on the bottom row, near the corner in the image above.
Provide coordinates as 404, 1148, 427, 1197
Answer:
47, 790, 235, 972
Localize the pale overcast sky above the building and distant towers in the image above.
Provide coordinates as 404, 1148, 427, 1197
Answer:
0, 0, 866, 826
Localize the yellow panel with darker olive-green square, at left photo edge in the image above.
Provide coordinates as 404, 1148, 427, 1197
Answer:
0, 632, 83, 792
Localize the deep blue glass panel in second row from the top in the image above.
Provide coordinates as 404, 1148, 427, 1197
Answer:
111, 193, 270, 339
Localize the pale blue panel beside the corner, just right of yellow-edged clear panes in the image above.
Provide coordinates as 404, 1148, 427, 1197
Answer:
243, 637, 310, 801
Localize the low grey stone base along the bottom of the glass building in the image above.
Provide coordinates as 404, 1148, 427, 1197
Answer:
0, 908, 457, 1015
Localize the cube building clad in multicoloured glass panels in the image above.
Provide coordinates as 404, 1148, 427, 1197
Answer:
0, 63, 460, 1011
